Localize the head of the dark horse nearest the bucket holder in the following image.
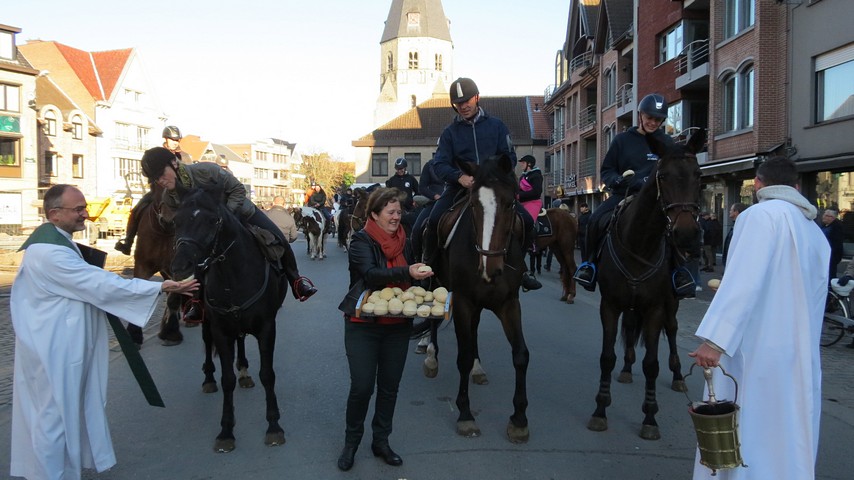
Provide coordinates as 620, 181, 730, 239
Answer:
647, 129, 706, 252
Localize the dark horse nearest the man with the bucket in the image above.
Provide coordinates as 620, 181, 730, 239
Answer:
587, 130, 706, 440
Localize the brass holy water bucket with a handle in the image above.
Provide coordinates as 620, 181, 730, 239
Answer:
685, 364, 747, 476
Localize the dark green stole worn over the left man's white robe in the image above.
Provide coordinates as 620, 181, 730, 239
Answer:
18, 223, 165, 407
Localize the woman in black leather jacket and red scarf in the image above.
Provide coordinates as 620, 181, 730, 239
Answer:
338, 188, 433, 471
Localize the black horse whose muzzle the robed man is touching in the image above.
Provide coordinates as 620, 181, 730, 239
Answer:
172, 190, 287, 452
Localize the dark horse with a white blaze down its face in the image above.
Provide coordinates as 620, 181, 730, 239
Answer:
425, 155, 529, 443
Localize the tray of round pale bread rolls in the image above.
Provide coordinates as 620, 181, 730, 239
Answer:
356, 286, 453, 320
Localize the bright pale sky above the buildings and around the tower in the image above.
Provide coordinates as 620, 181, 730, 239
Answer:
6, 0, 570, 161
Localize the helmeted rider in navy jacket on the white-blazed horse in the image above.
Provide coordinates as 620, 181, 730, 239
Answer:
415, 78, 543, 291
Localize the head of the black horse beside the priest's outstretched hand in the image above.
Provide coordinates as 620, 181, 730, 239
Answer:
172, 188, 227, 279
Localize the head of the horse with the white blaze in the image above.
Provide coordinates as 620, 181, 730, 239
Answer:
457, 154, 521, 282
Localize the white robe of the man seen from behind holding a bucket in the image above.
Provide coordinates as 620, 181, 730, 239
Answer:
694, 192, 830, 480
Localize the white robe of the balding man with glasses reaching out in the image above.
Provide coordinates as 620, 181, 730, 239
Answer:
10, 232, 160, 480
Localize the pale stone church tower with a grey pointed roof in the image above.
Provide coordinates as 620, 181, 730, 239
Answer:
374, 0, 454, 127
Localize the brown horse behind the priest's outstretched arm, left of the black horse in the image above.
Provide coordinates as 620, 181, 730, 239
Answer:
127, 184, 184, 346
